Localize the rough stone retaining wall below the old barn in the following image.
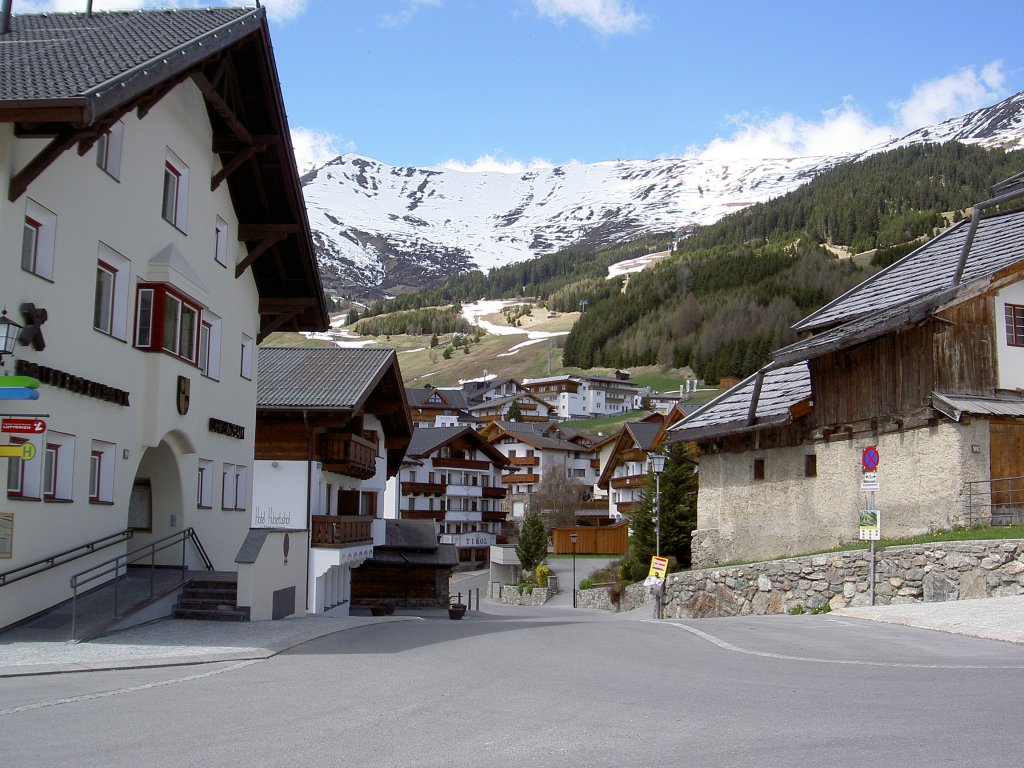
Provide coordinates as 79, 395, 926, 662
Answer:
663, 540, 1024, 618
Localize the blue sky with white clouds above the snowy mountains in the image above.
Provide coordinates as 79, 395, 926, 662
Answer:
19, 0, 1024, 171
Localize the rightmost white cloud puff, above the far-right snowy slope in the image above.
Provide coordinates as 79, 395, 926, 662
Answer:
890, 61, 1006, 133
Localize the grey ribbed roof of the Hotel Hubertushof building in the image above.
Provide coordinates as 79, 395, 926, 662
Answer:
256, 347, 395, 411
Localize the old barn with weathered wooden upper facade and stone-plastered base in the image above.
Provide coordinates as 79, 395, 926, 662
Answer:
671, 177, 1024, 565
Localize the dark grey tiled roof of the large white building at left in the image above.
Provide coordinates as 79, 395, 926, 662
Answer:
0, 8, 262, 122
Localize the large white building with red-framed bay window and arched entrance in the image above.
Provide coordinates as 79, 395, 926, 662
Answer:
0, 8, 327, 627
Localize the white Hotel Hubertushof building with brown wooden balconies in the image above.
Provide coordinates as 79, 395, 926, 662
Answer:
253, 347, 413, 615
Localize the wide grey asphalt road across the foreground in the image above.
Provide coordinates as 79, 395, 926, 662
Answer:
0, 602, 1024, 768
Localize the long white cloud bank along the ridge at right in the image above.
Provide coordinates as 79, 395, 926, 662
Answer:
686, 61, 1005, 161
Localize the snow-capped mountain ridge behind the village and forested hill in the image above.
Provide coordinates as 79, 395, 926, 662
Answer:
302, 92, 1024, 297
